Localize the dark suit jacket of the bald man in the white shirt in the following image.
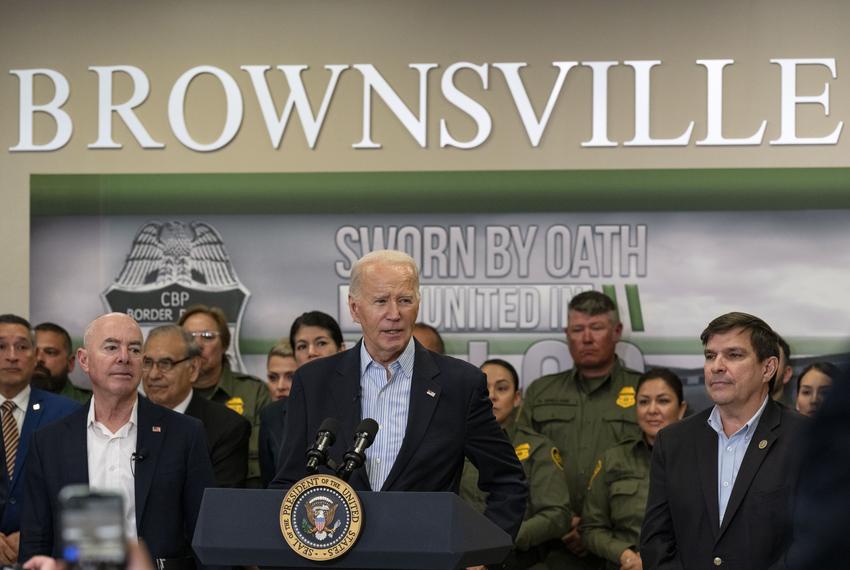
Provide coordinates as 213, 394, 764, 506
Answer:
20, 396, 214, 560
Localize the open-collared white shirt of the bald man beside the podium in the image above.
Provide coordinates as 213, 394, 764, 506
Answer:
86, 396, 139, 539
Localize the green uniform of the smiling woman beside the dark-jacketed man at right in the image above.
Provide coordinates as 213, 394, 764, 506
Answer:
580, 438, 652, 570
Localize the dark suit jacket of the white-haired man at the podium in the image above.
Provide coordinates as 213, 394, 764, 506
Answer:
271, 341, 528, 537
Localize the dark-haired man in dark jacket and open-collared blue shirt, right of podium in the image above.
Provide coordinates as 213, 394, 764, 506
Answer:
640, 313, 806, 570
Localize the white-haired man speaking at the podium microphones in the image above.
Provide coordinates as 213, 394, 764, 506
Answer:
270, 250, 528, 537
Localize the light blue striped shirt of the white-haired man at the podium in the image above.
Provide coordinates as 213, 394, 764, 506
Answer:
360, 338, 415, 491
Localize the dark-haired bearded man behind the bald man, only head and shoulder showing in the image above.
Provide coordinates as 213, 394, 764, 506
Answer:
32, 323, 91, 404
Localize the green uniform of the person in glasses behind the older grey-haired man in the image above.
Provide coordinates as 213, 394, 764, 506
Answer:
195, 366, 271, 489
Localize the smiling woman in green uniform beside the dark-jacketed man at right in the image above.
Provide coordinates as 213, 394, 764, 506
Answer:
580, 368, 688, 570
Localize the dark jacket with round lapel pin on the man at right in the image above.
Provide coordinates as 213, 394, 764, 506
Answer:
640, 400, 806, 570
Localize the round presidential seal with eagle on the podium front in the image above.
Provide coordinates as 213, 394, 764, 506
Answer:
280, 475, 363, 560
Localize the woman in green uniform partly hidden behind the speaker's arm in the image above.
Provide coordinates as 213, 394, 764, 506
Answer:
460, 359, 572, 569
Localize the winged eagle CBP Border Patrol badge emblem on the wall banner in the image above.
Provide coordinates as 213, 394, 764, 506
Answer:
101, 220, 251, 368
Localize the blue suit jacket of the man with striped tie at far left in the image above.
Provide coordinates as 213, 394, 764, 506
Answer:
0, 388, 81, 534
